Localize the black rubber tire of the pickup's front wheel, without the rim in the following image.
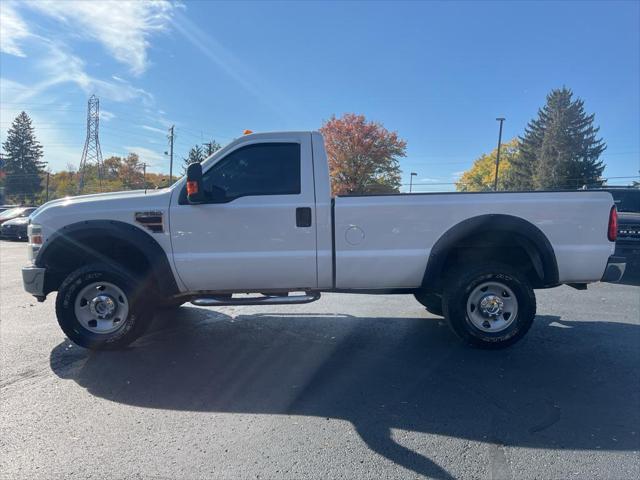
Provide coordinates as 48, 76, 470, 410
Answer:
56, 263, 156, 350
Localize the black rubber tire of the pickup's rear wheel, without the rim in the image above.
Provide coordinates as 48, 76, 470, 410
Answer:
442, 262, 536, 349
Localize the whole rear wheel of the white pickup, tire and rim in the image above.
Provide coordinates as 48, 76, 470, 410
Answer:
442, 263, 536, 348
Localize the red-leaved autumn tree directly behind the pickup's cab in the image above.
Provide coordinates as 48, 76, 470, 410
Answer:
320, 113, 407, 195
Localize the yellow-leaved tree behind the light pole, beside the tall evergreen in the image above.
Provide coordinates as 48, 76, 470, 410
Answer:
456, 138, 520, 192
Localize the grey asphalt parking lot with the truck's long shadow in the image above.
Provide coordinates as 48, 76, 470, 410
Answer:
0, 241, 640, 479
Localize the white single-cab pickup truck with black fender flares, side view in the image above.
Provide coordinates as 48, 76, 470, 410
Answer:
22, 132, 625, 349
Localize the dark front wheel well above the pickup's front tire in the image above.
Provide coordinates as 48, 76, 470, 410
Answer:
38, 235, 155, 293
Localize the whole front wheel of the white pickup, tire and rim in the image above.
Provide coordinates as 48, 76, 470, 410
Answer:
56, 264, 153, 350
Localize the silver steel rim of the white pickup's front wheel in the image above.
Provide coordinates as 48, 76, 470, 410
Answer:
74, 282, 129, 334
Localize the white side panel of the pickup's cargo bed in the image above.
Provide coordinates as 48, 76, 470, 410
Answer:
334, 191, 614, 289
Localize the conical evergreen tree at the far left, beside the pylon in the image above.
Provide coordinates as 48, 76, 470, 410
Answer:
2, 112, 45, 203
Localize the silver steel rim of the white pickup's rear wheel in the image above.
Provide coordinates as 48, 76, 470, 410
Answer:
467, 281, 518, 333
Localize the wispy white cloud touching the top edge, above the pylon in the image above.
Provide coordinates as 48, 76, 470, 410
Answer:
27, 0, 176, 75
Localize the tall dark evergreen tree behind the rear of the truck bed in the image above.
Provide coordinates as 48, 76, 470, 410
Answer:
506, 87, 607, 190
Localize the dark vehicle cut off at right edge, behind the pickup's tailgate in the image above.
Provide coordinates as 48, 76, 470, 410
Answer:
603, 188, 640, 285
